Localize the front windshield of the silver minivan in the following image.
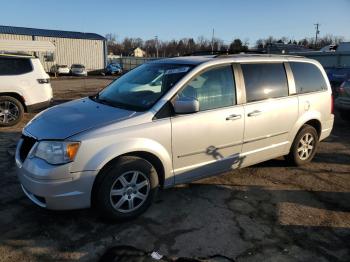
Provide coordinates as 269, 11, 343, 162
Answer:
94, 63, 192, 111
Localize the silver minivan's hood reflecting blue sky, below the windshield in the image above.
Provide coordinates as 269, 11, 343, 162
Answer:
24, 98, 136, 140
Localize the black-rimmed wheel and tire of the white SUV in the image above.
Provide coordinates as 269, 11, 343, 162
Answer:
0, 96, 24, 127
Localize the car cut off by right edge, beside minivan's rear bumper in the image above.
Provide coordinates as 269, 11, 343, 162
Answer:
335, 79, 350, 120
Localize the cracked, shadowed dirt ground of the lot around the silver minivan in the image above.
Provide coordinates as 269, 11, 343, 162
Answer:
0, 77, 350, 261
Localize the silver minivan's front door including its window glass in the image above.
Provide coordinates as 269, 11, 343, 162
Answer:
171, 65, 244, 183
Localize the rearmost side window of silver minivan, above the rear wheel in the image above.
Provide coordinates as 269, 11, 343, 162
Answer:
289, 62, 327, 94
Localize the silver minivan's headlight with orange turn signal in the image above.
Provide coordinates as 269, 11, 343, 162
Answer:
34, 141, 80, 165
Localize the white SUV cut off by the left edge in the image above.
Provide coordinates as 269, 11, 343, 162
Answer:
0, 55, 52, 127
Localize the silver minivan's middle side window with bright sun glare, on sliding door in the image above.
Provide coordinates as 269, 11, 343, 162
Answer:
241, 63, 288, 102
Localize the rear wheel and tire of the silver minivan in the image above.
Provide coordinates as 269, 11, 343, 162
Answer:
285, 125, 319, 166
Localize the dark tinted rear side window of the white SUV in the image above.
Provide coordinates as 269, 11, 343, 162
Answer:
0, 57, 33, 75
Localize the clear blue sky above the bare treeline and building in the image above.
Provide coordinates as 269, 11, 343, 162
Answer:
0, 0, 350, 45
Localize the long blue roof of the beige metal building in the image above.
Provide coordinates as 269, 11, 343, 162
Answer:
0, 25, 106, 40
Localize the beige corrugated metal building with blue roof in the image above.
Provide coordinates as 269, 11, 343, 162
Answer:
0, 26, 107, 72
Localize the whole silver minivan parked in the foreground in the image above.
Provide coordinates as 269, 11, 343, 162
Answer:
16, 55, 334, 219
